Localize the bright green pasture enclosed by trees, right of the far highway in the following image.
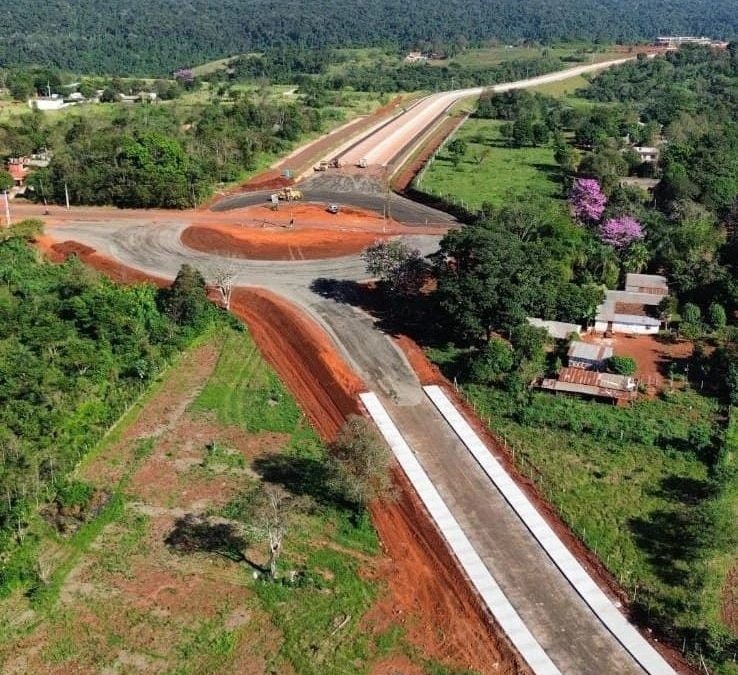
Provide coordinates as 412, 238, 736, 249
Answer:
415, 119, 561, 210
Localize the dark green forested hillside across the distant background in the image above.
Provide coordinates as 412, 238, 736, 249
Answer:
0, 0, 738, 74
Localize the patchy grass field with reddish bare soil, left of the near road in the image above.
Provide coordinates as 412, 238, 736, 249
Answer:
0, 329, 432, 675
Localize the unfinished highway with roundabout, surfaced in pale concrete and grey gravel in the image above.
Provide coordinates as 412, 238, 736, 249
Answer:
38, 59, 674, 674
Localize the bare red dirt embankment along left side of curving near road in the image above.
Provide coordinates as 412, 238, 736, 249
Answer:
39, 239, 530, 675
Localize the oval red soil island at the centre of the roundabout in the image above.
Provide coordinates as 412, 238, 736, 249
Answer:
181, 225, 377, 260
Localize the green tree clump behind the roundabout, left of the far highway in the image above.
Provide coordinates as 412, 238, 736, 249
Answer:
0, 93, 323, 208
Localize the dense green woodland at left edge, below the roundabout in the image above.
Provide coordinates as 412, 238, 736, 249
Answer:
0, 228, 220, 595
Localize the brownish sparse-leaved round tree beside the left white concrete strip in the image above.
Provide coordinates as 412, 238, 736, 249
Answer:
327, 415, 391, 509
